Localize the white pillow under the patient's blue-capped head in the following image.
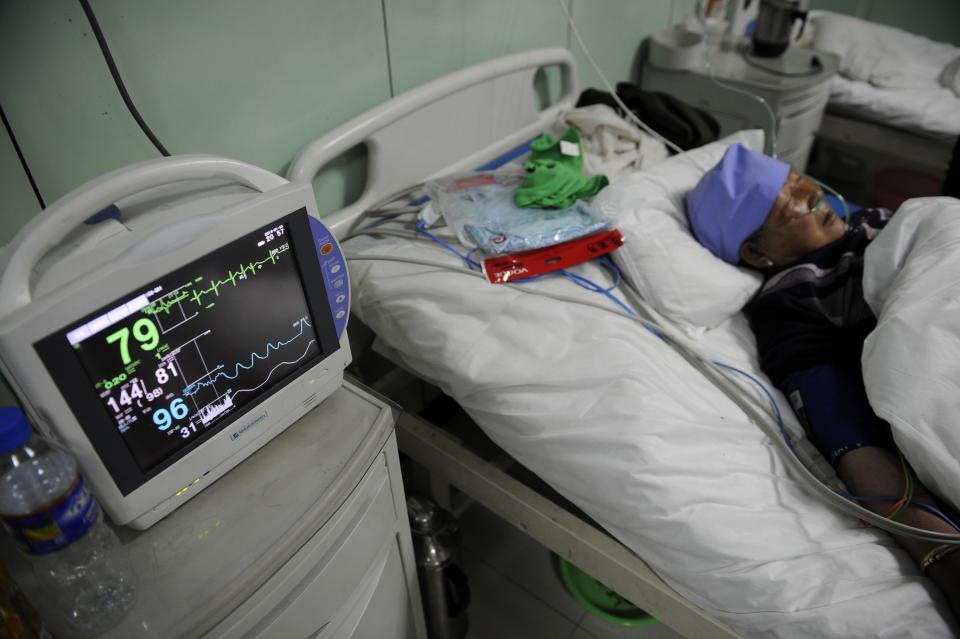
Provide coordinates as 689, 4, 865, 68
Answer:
597, 130, 763, 337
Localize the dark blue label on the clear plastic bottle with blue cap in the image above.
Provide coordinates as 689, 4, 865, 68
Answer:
3, 473, 99, 555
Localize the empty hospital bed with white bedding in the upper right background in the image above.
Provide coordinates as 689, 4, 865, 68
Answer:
810, 11, 960, 204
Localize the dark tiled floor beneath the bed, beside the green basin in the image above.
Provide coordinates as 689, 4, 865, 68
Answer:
459, 504, 680, 639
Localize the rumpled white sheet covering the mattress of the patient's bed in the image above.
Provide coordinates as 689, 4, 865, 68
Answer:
345, 238, 951, 638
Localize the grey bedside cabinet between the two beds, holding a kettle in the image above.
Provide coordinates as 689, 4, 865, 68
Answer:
640, 47, 839, 171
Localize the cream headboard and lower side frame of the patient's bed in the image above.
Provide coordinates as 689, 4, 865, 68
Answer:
288, 48, 738, 639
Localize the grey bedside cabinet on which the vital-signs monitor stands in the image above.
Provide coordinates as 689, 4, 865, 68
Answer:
4, 381, 426, 639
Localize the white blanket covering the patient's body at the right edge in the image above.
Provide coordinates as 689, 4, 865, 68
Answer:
862, 197, 960, 507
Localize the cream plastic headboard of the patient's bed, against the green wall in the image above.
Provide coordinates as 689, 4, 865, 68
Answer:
287, 48, 578, 237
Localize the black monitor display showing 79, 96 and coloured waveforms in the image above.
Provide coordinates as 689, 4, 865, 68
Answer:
61, 221, 322, 472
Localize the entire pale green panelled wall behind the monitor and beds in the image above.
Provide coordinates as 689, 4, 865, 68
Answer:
0, 0, 960, 244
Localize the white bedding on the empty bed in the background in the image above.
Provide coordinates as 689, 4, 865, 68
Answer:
811, 11, 960, 141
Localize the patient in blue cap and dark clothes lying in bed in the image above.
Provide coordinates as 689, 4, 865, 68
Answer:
687, 144, 960, 618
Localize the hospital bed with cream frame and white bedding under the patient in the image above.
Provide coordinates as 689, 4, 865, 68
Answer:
288, 49, 951, 637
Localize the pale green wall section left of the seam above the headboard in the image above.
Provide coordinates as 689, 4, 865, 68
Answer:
0, 0, 390, 244
